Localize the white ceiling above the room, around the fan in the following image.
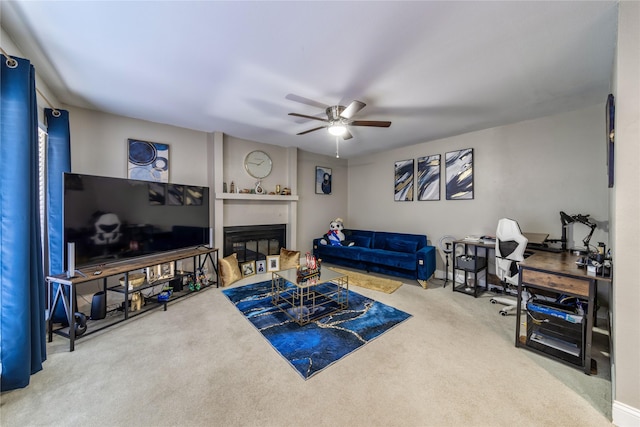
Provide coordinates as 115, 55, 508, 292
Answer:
1, 1, 618, 158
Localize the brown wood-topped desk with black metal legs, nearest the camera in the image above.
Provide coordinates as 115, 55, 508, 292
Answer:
516, 251, 612, 375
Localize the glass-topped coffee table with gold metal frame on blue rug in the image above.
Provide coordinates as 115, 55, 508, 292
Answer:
271, 268, 349, 325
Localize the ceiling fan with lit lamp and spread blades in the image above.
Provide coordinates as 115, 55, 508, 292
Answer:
289, 100, 391, 139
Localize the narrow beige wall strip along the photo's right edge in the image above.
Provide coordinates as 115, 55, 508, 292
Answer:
612, 1, 640, 426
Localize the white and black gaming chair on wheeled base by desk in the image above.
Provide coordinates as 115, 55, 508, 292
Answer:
490, 218, 529, 316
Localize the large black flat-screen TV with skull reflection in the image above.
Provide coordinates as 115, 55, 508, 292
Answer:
63, 173, 210, 267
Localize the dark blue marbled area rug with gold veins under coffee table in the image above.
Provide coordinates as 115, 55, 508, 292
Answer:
222, 281, 411, 380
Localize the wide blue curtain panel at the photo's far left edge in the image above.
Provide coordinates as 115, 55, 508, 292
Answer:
0, 56, 46, 391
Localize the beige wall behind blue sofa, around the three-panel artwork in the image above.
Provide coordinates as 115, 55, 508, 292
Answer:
347, 105, 609, 277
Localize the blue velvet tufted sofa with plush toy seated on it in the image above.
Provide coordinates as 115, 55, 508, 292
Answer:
313, 230, 436, 285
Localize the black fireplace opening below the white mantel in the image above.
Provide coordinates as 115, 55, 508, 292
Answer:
223, 224, 287, 262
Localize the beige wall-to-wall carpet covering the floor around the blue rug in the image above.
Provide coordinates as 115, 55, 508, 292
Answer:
0, 266, 611, 427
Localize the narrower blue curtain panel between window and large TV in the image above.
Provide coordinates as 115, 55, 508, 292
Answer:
44, 108, 71, 323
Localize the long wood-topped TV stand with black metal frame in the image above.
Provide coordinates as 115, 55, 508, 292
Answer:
46, 247, 219, 351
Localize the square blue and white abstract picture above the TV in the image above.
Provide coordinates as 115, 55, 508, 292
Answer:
127, 139, 169, 182
